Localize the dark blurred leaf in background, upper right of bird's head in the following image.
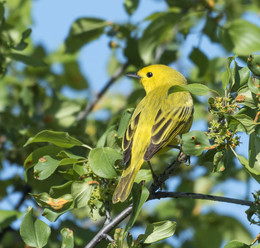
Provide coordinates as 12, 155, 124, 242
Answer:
189, 48, 209, 77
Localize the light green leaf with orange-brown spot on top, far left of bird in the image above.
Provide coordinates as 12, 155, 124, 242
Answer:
34, 155, 60, 180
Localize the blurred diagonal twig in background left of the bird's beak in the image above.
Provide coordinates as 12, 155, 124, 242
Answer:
76, 63, 129, 121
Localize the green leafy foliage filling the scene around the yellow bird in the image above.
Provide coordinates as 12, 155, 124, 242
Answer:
0, 0, 260, 248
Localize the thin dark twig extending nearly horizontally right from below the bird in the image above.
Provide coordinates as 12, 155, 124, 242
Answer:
151, 191, 253, 206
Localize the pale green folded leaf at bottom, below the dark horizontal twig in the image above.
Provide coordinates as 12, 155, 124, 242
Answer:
143, 220, 176, 244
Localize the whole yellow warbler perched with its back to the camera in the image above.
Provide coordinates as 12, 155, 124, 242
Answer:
112, 65, 194, 203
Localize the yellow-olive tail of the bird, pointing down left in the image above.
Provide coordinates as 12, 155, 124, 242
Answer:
112, 163, 142, 204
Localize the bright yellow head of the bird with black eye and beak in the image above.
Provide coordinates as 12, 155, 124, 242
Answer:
126, 65, 187, 94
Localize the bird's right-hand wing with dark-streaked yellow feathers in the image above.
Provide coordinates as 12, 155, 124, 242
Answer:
143, 92, 194, 161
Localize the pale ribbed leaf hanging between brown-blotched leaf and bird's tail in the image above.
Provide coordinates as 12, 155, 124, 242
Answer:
71, 177, 93, 208
